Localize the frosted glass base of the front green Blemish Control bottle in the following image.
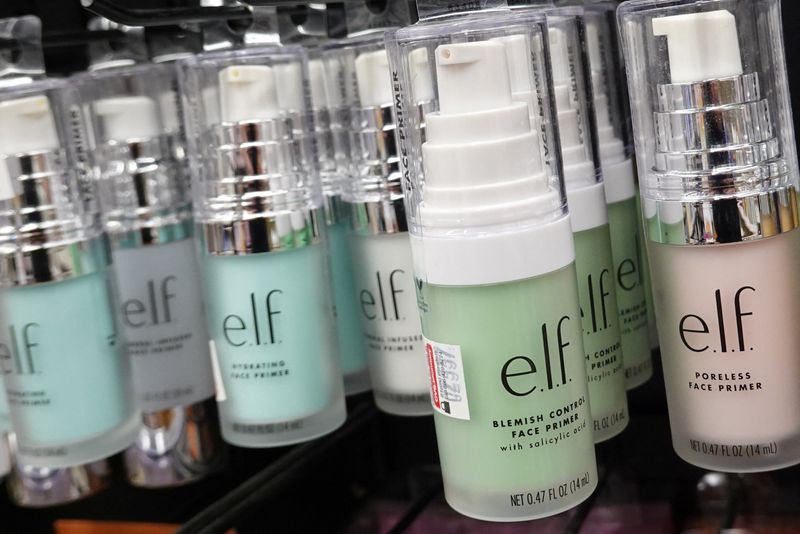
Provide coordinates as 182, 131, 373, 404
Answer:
444, 480, 597, 523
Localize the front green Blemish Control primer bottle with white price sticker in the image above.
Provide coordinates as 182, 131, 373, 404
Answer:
387, 12, 597, 521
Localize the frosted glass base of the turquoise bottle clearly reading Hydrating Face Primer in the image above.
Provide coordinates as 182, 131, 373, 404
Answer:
221, 395, 347, 449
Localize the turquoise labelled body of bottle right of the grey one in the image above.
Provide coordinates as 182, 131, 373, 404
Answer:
204, 245, 342, 439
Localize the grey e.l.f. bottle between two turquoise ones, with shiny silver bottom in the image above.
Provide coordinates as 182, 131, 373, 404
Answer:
76, 64, 222, 487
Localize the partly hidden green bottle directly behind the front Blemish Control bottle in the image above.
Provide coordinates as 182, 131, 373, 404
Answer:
544, 12, 629, 442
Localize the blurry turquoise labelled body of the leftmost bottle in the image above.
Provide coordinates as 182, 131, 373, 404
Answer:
0, 273, 132, 458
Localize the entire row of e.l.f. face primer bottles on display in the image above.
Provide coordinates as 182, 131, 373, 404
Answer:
0, 0, 800, 520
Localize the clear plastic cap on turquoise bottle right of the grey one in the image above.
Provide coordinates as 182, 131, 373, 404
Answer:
180, 46, 322, 225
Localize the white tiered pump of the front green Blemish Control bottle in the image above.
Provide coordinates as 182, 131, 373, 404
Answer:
412, 37, 573, 285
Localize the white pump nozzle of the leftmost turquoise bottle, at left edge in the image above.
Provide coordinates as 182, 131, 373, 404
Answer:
0, 95, 59, 155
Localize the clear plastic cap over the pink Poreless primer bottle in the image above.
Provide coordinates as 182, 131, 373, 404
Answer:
619, 0, 798, 205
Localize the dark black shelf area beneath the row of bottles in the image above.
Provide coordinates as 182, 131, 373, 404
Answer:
0, 352, 800, 534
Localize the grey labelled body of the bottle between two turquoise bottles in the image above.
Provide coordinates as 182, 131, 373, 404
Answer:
114, 239, 214, 412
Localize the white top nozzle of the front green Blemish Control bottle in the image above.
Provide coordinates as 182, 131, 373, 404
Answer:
436, 41, 512, 114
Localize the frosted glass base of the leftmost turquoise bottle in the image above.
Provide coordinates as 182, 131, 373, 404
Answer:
16, 413, 141, 469
